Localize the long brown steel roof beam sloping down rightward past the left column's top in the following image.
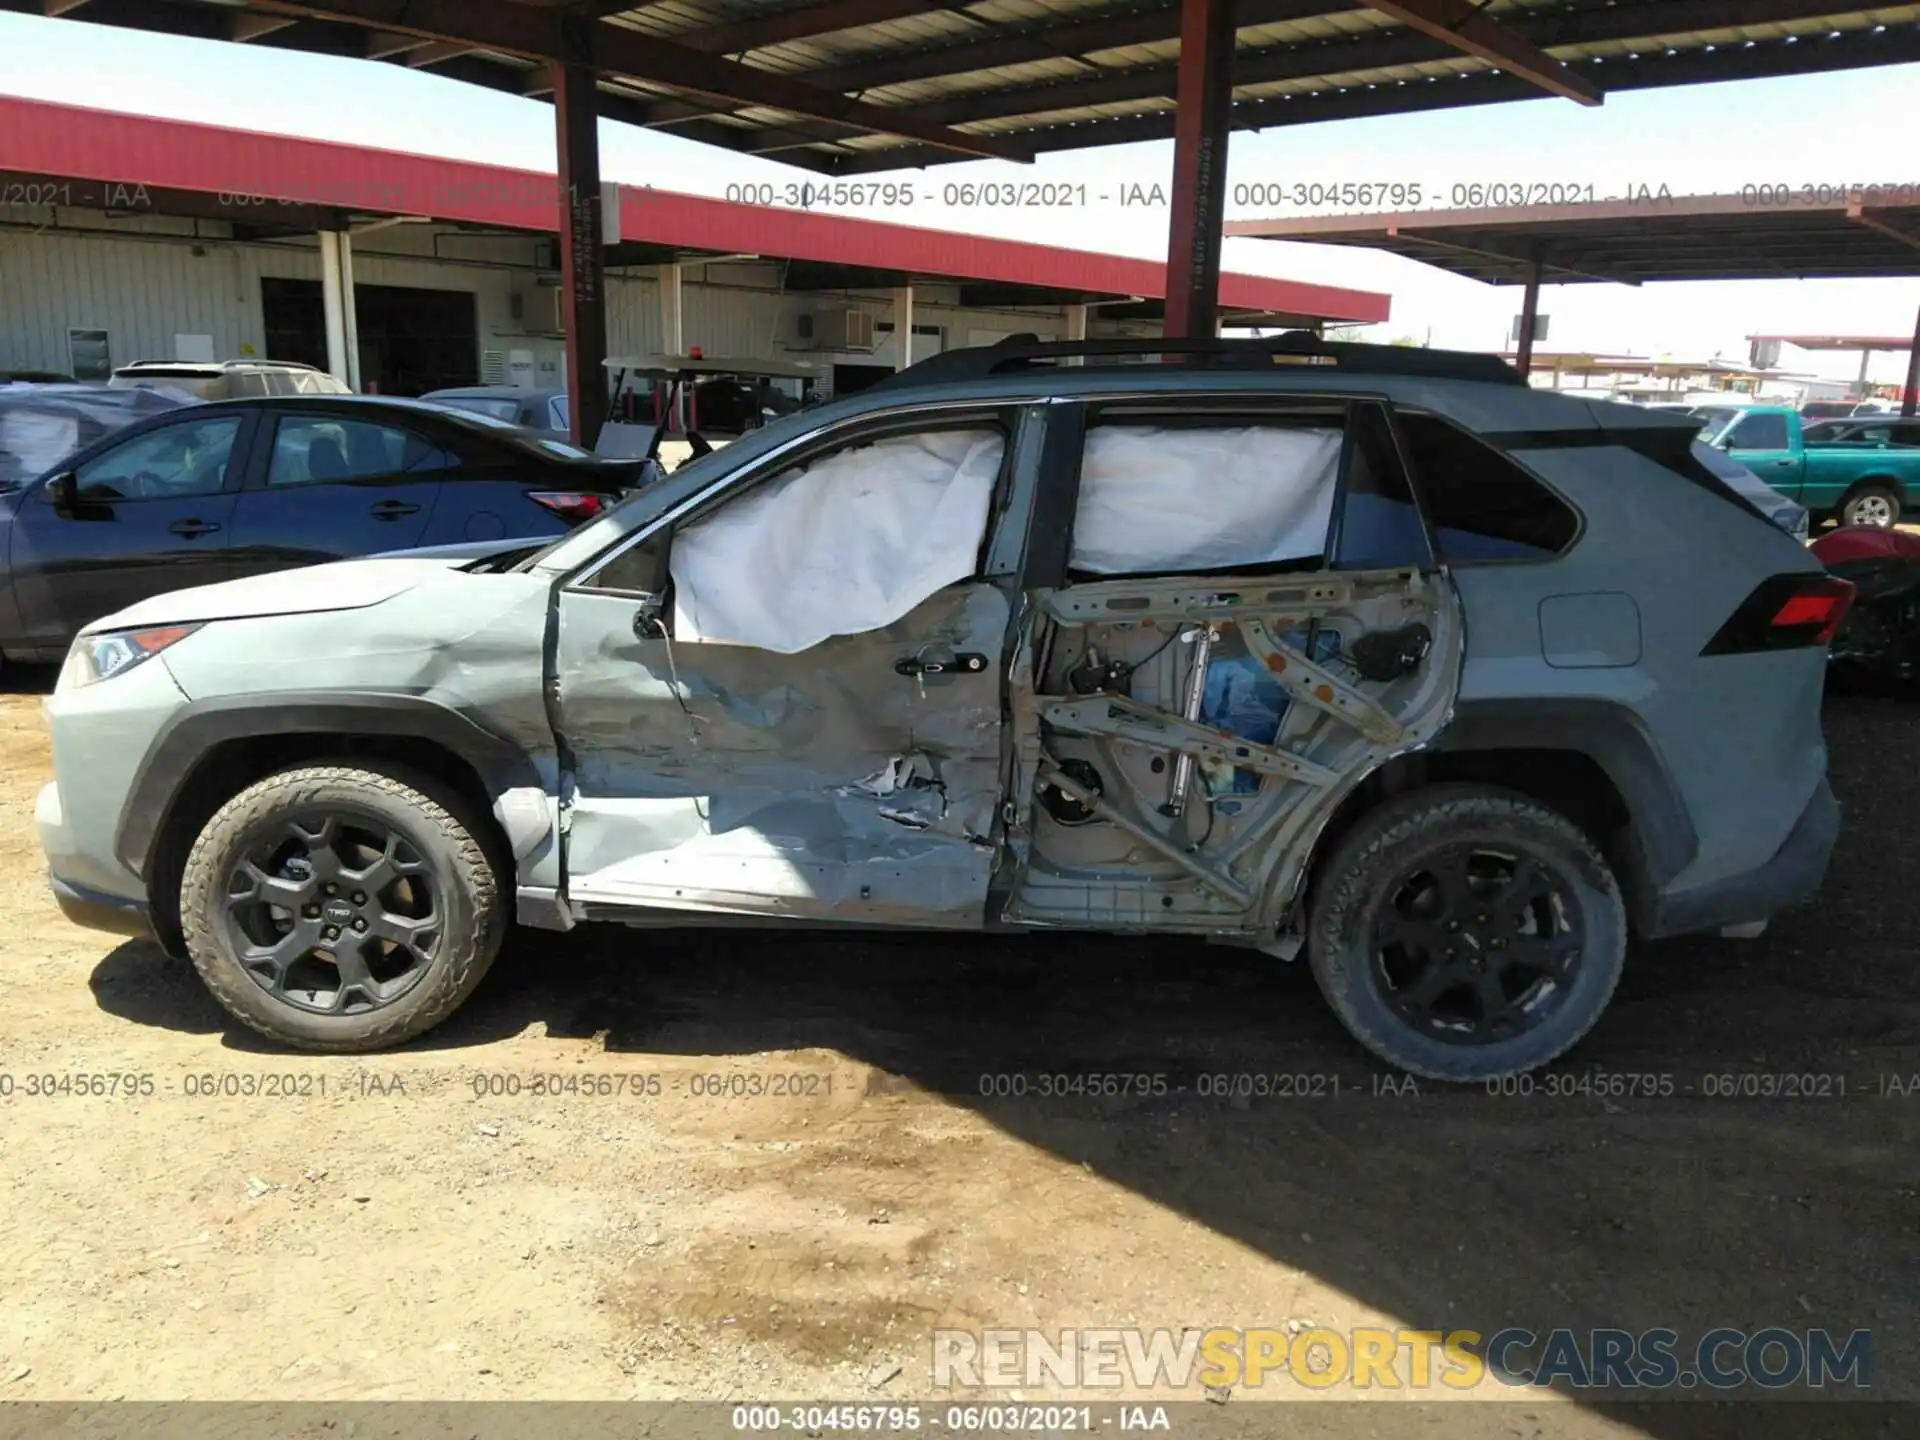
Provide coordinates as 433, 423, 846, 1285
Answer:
257, 0, 1033, 161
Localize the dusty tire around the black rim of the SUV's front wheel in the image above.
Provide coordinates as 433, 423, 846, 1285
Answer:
180, 762, 511, 1054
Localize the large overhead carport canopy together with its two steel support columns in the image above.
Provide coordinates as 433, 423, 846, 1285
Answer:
22, 0, 1920, 434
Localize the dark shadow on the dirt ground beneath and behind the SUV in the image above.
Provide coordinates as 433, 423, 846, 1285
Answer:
94, 697, 1920, 1436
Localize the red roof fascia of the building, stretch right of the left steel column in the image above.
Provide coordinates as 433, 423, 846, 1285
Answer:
620, 186, 1392, 323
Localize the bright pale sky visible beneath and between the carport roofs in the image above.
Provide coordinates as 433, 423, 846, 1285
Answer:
0, 12, 1920, 382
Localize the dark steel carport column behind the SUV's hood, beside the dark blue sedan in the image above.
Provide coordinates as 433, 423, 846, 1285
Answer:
551, 61, 607, 449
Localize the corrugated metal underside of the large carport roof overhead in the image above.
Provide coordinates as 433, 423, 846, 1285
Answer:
26, 0, 1920, 173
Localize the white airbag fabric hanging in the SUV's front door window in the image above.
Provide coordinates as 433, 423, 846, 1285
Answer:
672, 430, 1006, 655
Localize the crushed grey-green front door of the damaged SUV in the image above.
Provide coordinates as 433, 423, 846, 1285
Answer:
555, 414, 1018, 927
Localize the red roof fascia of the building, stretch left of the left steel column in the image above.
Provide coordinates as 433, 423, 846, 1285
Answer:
0, 96, 559, 230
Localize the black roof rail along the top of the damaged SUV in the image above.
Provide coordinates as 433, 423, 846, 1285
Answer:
868, 330, 1526, 390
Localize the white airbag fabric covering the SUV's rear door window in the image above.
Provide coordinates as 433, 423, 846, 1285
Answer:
1071, 424, 1340, 574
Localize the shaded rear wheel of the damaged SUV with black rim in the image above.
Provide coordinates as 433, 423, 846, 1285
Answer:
1311, 785, 1626, 1081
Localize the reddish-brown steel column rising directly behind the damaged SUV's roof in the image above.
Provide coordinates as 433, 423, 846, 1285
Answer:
1162, 0, 1235, 340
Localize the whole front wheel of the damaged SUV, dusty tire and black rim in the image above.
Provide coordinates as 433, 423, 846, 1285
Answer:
180, 764, 505, 1050
